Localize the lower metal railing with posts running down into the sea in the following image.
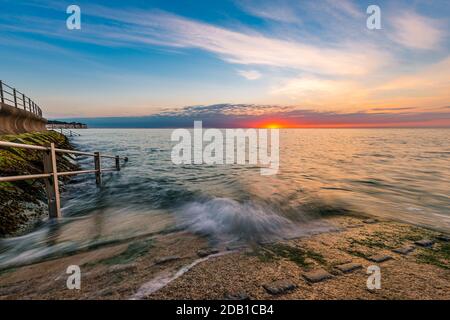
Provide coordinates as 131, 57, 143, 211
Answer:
0, 141, 128, 218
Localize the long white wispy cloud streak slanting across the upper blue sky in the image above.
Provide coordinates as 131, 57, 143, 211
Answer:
0, 6, 391, 75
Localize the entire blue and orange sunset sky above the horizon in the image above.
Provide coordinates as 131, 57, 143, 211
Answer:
0, 0, 450, 127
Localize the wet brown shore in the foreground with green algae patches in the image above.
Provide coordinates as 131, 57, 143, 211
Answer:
0, 217, 450, 299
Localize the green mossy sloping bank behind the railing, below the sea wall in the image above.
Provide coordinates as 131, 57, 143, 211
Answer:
0, 131, 77, 237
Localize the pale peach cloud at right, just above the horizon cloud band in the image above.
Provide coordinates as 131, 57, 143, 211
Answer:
270, 56, 450, 110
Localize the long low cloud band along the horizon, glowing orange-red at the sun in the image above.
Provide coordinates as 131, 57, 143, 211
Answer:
61, 104, 450, 128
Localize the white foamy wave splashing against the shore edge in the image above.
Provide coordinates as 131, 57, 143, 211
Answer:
176, 198, 331, 243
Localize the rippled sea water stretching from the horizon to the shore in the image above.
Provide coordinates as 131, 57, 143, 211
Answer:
0, 129, 450, 267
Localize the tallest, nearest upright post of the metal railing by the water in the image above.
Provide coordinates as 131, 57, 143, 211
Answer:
44, 143, 61, 218
